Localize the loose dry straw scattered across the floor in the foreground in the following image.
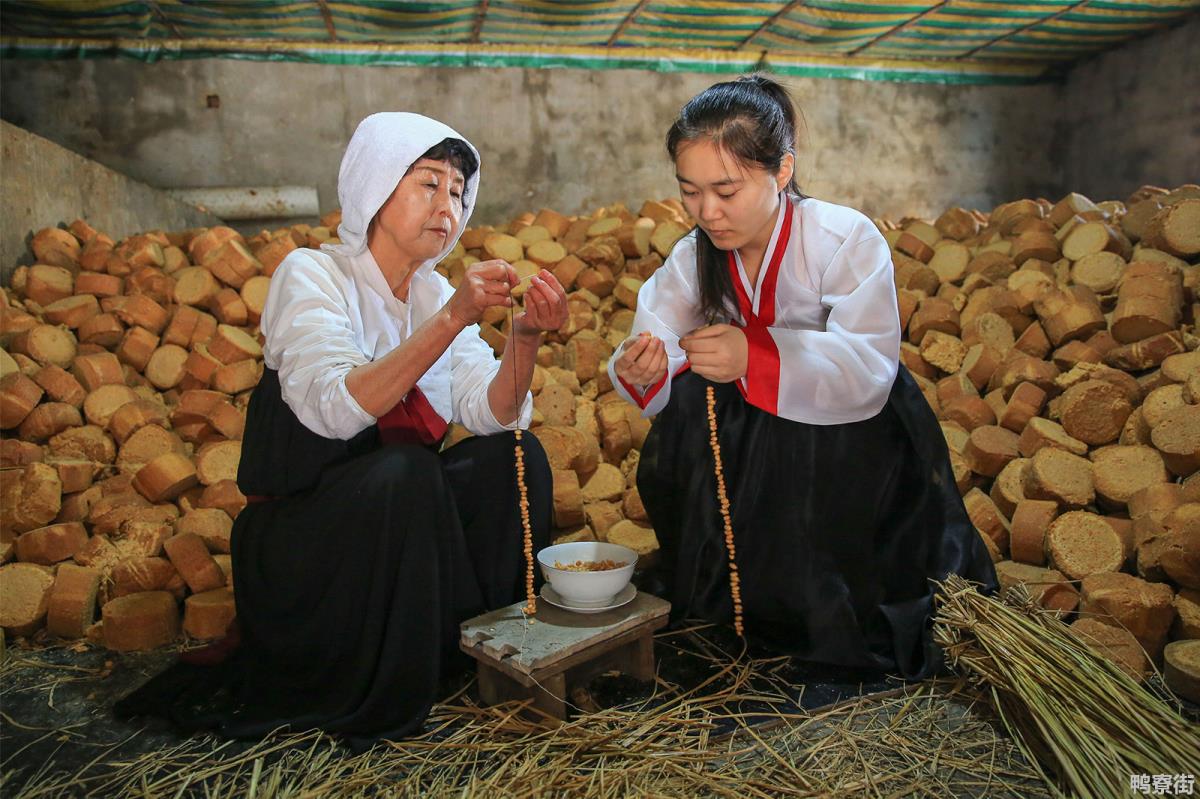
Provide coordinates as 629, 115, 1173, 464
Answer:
0, 627, 1050, 799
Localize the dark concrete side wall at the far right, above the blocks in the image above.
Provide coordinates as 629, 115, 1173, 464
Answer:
1060, 14, 1200, 198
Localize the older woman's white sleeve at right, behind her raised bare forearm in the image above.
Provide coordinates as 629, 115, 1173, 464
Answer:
438, 275, 533, 435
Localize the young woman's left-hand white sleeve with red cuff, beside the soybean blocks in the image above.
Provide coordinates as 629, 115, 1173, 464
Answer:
608, 234, 704, 416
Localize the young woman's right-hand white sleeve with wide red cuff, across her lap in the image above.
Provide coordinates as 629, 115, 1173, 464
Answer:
744, 224, 900, 425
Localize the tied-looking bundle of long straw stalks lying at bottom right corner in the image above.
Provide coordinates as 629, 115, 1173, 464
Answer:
934, 575, 1200, 799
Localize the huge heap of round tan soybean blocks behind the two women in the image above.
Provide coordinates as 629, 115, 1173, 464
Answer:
0, 186, 1200, 705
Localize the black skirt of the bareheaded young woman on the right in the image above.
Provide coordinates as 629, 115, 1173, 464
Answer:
637, 365, 996, 679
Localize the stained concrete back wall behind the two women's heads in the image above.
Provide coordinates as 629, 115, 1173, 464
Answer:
0, 59, 1056, 222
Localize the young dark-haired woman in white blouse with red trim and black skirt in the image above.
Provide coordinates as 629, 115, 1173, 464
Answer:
610, 76, 996, 678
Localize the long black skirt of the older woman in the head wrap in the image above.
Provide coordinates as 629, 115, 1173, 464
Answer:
116, 370, 552, 746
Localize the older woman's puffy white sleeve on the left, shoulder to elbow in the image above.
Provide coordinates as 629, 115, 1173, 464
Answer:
259, 251, 376, 439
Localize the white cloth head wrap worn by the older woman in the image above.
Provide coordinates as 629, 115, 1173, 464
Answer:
322, 112, 479, 265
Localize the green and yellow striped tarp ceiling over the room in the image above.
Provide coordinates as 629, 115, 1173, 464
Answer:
0, 0, 1200, 83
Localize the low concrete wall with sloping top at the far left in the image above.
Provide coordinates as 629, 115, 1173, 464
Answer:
0, 122, 220, 286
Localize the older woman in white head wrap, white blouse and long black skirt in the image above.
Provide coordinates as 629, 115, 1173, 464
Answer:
119, 113, 566, 743
